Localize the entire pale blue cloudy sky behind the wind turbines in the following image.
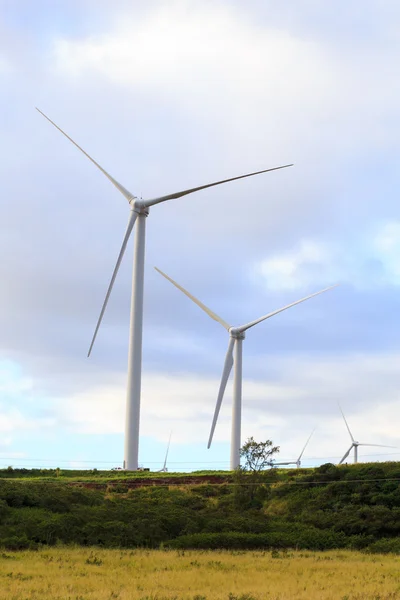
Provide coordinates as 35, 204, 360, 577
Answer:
0, 0, 400, 469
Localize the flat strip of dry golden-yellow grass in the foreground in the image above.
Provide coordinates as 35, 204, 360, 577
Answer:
0, 548, 400, 600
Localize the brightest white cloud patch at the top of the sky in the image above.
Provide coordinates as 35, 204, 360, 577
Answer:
54, 2, 330, 109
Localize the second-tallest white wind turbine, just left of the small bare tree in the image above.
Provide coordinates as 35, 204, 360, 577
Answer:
154, 267, 336, 471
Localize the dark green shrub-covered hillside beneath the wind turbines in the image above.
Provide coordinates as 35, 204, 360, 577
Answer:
0, 462, 400, 552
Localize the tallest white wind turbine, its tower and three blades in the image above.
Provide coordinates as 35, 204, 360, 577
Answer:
37, 109, 292, 471
